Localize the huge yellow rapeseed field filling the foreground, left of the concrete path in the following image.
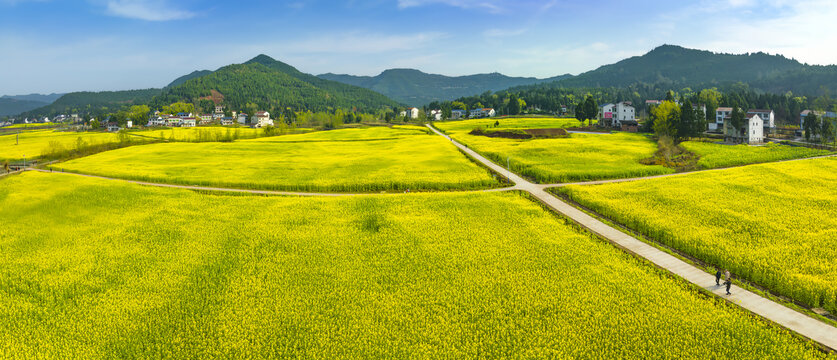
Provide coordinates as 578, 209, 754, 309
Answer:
0, 172, 834, 359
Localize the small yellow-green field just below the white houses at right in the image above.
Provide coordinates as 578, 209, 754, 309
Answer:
681, 141, 830, 169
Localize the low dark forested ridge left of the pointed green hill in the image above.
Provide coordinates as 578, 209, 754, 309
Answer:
21, 89, 162, 117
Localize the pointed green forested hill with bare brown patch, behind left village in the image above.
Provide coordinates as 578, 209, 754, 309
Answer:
151, 55, 399, 112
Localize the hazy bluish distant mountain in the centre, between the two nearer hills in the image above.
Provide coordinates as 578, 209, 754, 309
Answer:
319, 69, 570, 106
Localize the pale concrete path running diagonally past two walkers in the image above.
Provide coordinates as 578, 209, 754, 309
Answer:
427, 125, 837, 351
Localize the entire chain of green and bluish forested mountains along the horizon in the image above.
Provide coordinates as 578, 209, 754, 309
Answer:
9, 45, 837, 119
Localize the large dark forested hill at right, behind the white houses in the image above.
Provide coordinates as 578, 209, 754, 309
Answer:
549, 45, 837, 95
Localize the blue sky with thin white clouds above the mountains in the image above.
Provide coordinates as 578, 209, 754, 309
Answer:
0, 0, 837, 95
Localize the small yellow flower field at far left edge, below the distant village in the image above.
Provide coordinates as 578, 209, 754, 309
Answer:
0, 130, 118, 161
